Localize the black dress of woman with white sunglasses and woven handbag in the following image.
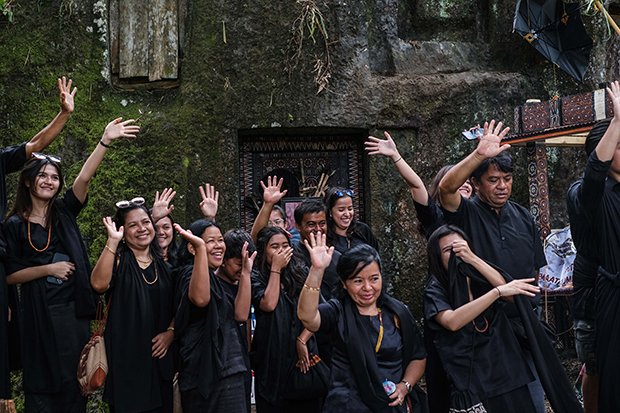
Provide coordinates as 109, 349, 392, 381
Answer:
103, 248, 174, 413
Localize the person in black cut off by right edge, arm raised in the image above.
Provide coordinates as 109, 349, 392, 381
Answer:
577, 81, 620, 412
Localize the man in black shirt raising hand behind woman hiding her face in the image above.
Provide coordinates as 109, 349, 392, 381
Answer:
439, 121, 547, 413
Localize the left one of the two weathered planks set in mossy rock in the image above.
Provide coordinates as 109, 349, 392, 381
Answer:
119, 0, 149, 78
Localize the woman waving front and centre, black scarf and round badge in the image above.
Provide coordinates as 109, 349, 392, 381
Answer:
299, 232, 427, 413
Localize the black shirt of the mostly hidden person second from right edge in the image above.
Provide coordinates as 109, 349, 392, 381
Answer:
566, 177, 600, 320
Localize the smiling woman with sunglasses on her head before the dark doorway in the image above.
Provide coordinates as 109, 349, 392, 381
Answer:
323, 187, 379, 253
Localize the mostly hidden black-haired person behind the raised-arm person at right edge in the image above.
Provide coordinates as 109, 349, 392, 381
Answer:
566, 119, 610, 413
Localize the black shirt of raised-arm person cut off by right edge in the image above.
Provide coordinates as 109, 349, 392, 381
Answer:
578, 151, 620, 274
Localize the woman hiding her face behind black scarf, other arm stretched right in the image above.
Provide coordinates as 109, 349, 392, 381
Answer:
424, 225, 539, 413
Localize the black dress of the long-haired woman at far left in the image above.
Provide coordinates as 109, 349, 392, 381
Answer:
4, 189, 96, 412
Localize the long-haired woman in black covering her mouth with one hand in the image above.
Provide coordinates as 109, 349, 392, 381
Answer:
250, 226, 321, 413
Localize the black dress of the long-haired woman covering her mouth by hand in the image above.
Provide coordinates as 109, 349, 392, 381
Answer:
250, 270, 321, 413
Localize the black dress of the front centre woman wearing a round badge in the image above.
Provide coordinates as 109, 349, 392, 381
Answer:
319, 297, 426, 413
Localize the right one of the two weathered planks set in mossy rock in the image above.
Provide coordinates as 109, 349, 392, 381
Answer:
148, 0, 179, 82
